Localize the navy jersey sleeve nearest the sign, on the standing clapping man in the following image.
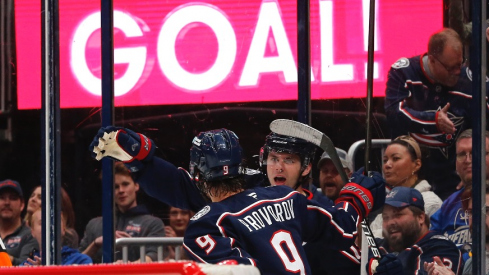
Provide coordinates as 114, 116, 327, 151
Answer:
385, 68, 439, 136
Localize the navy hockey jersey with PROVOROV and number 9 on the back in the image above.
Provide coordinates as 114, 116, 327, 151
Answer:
184, 186, 359, 274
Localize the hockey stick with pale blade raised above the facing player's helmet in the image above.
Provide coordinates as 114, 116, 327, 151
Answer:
270, 119, 381, 259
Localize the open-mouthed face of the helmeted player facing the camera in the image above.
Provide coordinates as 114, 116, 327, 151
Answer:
267, 151, 311, 188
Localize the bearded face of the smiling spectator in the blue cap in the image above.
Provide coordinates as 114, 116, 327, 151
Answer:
382, 204, 424, 252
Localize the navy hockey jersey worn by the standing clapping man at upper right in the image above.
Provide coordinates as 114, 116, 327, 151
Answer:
385, 56, 486, 200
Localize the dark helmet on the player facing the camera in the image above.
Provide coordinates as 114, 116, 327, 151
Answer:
259, 132, 317, 173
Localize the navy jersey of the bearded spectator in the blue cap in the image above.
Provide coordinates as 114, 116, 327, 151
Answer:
369, 231, 463, 275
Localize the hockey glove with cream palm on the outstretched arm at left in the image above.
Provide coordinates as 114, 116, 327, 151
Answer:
89, 126, 155, 172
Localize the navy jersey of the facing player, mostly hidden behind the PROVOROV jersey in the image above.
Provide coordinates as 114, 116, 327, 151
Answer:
133, 157, 360, 275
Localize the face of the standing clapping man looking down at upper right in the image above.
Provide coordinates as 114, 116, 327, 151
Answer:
430, 43, 464, 87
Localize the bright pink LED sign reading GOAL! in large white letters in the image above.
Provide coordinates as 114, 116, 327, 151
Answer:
15, 0, 442, 109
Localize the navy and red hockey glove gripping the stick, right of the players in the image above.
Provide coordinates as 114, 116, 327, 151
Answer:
336, 168, 385, 218
